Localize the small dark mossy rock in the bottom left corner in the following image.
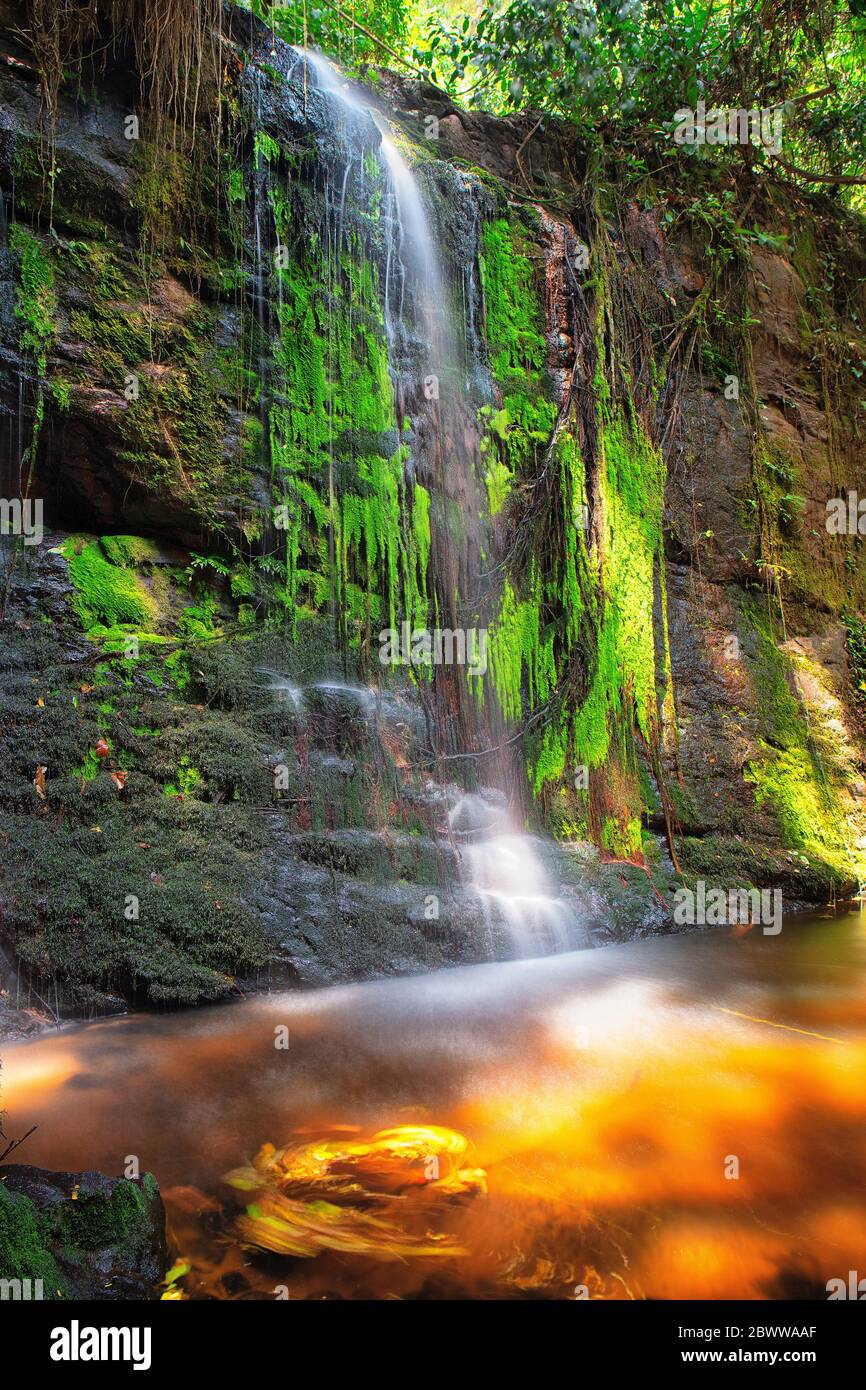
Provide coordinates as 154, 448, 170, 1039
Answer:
0, 1163, 165, 1300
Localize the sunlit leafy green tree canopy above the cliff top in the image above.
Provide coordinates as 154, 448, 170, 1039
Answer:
240, 0, 866, 203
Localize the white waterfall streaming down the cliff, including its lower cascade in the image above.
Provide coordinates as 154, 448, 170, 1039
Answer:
264, 49, 580, 958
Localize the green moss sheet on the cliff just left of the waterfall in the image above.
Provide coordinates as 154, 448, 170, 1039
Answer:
268, 188, 430, 639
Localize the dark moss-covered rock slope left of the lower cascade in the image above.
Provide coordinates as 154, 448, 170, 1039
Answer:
0, 535, 497, 1016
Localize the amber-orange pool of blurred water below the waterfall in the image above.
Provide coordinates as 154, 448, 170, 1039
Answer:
3, 915, 866, 1298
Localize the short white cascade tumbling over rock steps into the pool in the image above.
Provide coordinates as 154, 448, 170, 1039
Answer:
449, 794, 577, 958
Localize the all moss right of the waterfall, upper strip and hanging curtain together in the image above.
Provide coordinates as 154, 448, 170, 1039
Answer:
484, 218, 673, 828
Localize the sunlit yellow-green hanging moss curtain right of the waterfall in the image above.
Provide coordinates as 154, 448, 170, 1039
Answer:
489, 406, 666, 806
